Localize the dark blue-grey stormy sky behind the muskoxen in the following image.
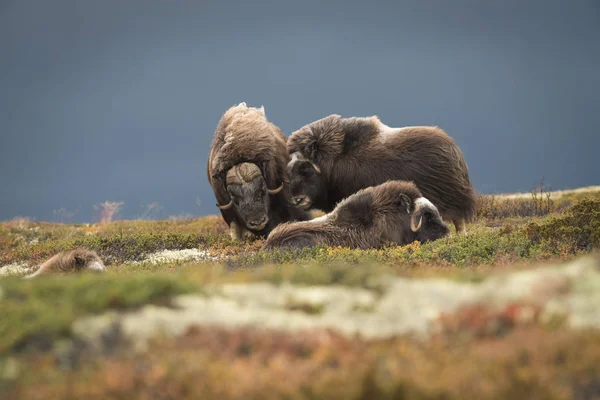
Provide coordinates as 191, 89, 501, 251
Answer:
0, 0, 600, 222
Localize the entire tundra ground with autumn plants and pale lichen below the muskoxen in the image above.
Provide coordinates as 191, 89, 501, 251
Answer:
0, 190, 600, 399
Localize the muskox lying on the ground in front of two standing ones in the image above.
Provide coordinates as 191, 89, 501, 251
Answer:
263, 181, 450, 249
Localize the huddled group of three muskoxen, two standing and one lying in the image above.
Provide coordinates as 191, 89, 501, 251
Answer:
207, 103, 475, 249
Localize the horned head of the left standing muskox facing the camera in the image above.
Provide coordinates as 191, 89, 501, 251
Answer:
217, 163, 283, 231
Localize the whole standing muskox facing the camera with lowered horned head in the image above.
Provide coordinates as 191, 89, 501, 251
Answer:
206, 103, 309, 240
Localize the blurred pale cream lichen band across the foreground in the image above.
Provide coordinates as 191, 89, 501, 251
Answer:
73, 256, 600, 351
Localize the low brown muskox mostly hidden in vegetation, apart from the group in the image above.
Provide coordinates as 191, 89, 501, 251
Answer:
24, 248, 106, 279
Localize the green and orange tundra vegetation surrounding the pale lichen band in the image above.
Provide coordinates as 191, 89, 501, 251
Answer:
0, 191, 600, 399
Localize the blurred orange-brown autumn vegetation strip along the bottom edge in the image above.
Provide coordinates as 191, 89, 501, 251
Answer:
6, 326, 600, 400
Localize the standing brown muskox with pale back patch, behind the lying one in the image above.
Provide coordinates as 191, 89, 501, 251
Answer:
287, 114, 476, 233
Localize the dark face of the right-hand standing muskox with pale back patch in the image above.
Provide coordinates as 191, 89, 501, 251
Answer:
287, 153, 323, 210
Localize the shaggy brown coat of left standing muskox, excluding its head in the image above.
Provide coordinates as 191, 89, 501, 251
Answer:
206, 103, 309, 237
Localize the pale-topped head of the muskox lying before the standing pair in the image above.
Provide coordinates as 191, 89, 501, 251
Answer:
410, 197, 450, 243
